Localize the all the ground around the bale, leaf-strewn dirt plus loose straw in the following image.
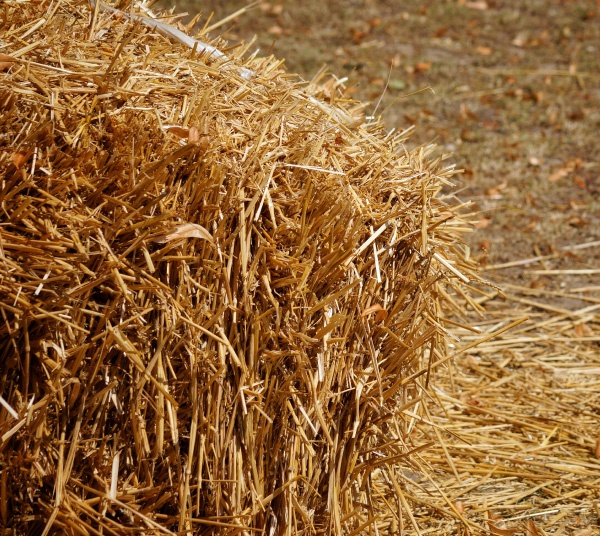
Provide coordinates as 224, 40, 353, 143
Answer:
156, 0, 600, 536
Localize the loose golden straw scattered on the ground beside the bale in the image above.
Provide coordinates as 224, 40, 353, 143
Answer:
405, 284, 600, 536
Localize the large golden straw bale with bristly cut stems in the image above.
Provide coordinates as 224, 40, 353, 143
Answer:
0, 0, 478, 534
